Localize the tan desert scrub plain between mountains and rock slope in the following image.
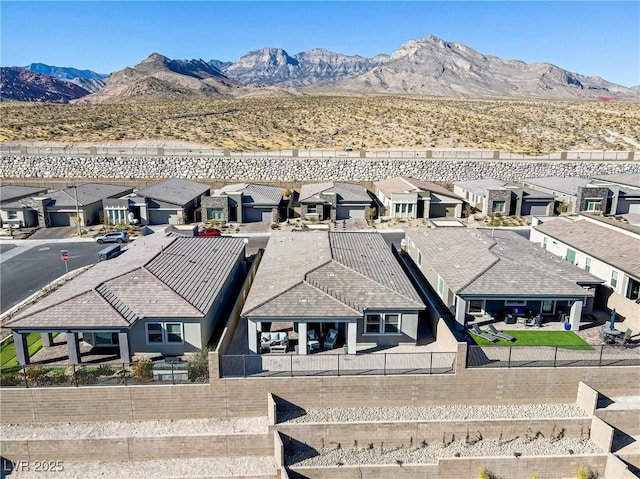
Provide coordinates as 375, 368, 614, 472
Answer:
0, 95, 640, 154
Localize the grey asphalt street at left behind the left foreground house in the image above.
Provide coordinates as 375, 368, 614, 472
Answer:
0, 241, 104, 312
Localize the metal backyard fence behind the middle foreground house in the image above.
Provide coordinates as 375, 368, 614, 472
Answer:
220, 352, 456, 378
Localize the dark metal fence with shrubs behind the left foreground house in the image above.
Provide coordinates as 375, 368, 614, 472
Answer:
0, 360, 209, 388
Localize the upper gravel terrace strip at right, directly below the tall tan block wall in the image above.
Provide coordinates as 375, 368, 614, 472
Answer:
278, 404, 588, 423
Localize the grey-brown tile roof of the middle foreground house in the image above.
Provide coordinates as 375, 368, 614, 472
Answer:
242, 231, 424, 317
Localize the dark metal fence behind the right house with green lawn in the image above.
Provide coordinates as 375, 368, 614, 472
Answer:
467, 345, 640, 368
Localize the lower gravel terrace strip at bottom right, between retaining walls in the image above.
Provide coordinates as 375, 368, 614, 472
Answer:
286, 437, 604, 466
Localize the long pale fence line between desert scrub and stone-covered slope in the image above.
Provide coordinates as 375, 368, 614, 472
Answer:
0, 145, 640, 161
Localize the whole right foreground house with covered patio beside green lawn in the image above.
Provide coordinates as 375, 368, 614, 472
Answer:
406, 228, 602, 329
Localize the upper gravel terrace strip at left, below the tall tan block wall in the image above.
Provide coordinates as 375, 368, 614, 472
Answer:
2, 417, 268, 441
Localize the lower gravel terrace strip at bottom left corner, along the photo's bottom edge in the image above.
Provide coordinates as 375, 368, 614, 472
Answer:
9, 457, 277, 479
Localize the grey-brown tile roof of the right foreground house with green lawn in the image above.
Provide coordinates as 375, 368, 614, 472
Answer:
407, 228, 602, 296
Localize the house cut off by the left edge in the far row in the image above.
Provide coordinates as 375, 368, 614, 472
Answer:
0, 185, 47, 228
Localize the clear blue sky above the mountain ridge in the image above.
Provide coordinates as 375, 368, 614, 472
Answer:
0, 0, 640, 86
